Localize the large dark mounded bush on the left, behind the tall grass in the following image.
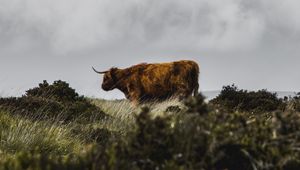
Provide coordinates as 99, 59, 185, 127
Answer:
0, 80, 105, 121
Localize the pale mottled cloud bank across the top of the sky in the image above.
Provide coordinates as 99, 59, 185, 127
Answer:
0, 0, 300, 53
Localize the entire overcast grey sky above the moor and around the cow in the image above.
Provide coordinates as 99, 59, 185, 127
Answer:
0, 0, 300, 98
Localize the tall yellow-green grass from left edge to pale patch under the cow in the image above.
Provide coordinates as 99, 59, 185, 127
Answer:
0, 99, 184, 159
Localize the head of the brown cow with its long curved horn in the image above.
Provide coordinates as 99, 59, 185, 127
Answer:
93, 67, 118, 91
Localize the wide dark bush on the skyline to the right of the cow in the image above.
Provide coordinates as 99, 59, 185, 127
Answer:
210, 85, 285, 112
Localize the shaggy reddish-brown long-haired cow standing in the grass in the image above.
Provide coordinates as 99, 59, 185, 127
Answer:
93, 60, 199, 103
